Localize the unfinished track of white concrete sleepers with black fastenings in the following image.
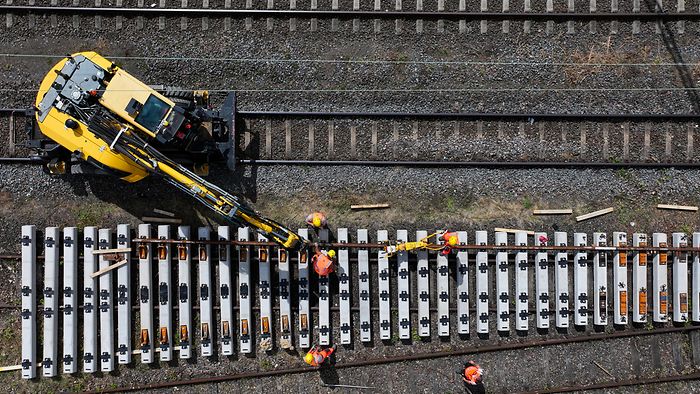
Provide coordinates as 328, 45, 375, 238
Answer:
13, 224, 700, 378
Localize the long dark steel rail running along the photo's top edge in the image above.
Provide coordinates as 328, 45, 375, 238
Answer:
0, 5, 700, 21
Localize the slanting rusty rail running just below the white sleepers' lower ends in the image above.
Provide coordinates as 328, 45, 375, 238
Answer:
86, 326, 700, 393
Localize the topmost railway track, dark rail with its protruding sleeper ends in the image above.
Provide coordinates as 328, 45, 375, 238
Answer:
0, 0, 700, 33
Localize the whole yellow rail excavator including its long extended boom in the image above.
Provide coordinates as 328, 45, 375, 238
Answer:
33, 52, 304, 250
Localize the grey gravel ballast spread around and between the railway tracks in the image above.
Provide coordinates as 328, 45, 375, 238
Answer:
0, 7, 700, 392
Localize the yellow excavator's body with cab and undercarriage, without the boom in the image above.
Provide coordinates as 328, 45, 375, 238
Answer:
35, 52, 235, 182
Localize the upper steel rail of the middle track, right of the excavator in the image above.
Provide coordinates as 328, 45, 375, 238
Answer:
236, 110, 700, 121
